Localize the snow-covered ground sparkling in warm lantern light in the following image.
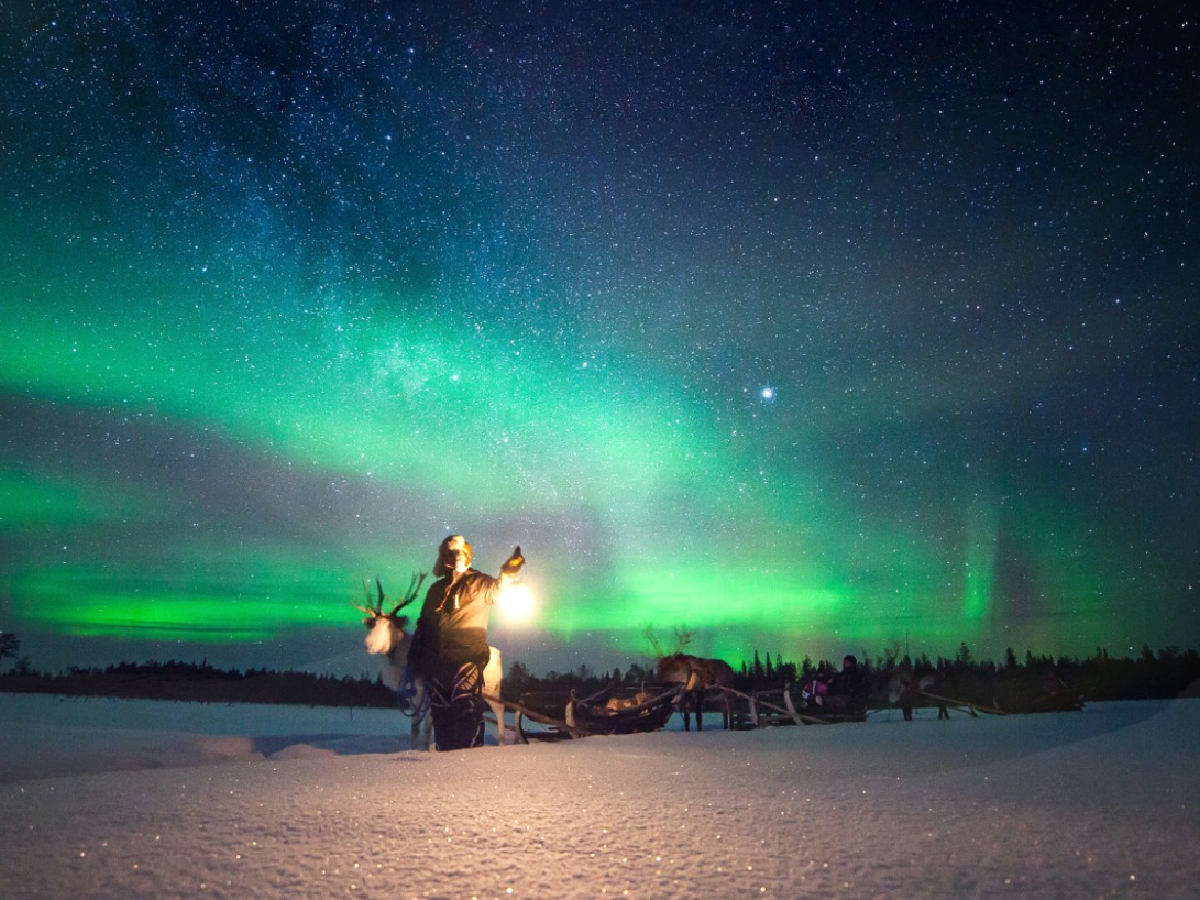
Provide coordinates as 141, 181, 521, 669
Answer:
0, 695, 1200, 900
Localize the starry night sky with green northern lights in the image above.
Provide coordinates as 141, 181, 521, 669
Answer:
0, 0, 1200, 673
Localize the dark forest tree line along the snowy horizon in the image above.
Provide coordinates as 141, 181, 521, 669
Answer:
0, 632, 1200, 707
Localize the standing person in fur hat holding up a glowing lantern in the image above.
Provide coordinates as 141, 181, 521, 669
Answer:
408, 534, 524, 750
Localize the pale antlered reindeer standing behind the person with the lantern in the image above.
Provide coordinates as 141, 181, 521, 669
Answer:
354, 572, 505, 750
